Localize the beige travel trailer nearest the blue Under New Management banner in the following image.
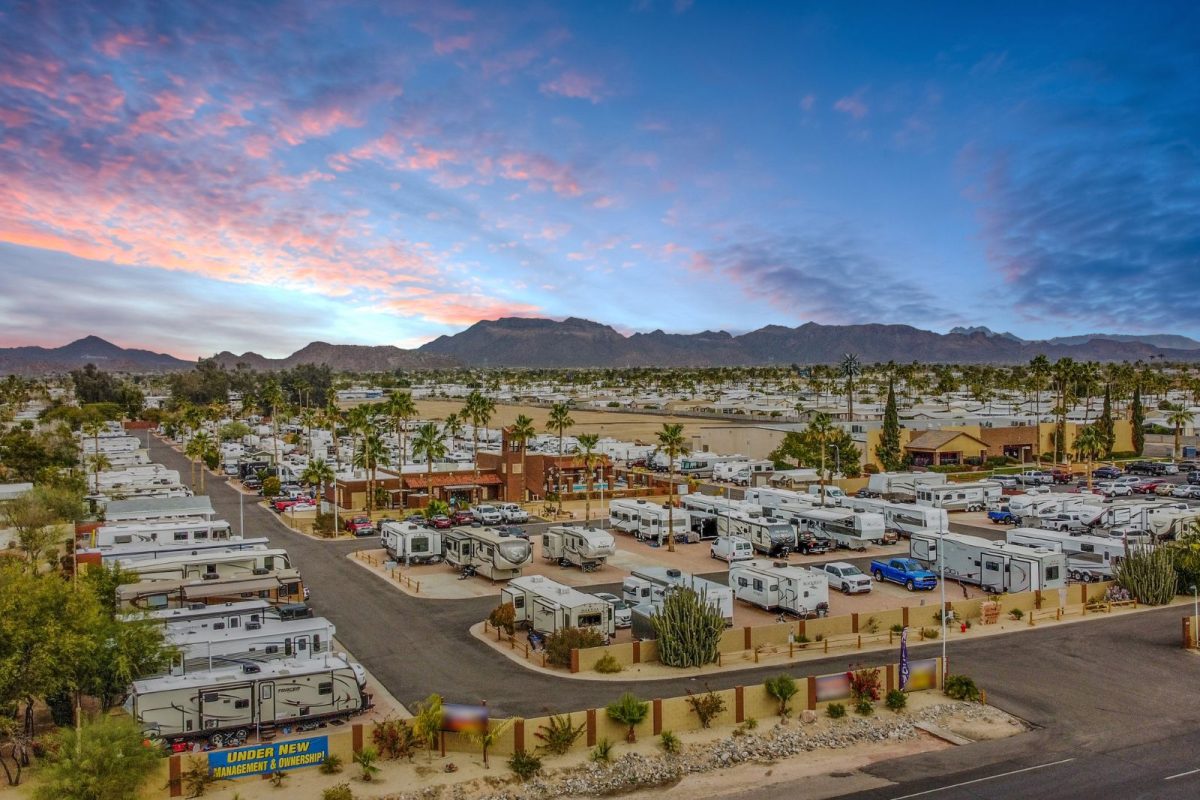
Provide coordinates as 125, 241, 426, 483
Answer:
125, 655, 370, 745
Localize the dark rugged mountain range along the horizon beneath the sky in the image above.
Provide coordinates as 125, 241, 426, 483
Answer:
0, 317, 1200, 374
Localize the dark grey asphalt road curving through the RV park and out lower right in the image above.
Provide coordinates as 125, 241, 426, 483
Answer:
151, 439, 1200, 800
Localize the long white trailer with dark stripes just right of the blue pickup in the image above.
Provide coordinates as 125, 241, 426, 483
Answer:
908, 534, 1068, 594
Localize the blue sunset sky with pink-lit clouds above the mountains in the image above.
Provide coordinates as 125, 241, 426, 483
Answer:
0, 0, 1200, 357
